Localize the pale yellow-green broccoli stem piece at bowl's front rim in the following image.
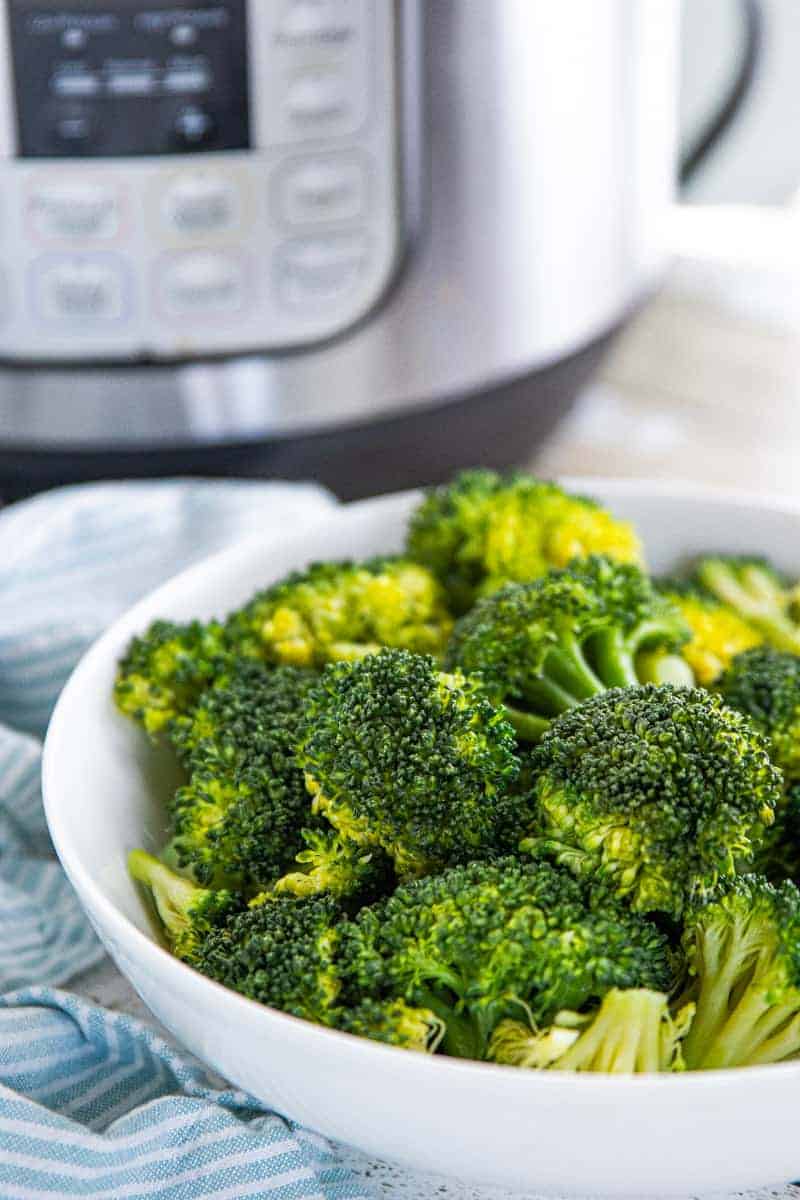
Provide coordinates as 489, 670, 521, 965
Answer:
488, 988, 694, 1074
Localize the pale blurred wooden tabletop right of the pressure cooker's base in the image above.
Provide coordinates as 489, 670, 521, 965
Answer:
533, 267, 800, 494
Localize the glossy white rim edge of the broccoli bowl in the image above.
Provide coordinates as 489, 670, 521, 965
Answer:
42, 475, 800, 1097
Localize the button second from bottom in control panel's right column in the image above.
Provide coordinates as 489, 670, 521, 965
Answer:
277, 156, 367, 226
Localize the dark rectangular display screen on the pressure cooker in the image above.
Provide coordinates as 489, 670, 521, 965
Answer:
10, 0, 249, 158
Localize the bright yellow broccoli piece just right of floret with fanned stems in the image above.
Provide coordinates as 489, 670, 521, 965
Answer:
654, 581, 764, 688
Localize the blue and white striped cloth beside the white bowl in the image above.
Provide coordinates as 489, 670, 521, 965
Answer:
0, 481, 374, 1200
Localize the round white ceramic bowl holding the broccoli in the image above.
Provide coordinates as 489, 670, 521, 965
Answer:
44, 480, 800, 1196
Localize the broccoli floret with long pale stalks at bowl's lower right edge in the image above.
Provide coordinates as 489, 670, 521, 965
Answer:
684, 875, 800, 1069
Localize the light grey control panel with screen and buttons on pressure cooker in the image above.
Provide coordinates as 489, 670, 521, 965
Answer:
0, 0, 407, 361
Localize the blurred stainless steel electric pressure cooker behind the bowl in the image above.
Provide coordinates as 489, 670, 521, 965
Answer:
0, 0, 753, 496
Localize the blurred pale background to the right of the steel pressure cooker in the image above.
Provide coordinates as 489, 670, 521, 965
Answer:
535, 0, 800, 493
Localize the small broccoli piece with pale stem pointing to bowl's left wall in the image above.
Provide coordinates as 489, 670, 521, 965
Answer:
128, 850, 241, 966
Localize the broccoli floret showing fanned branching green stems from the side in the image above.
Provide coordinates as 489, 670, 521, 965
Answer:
445, 557, 693, 742
